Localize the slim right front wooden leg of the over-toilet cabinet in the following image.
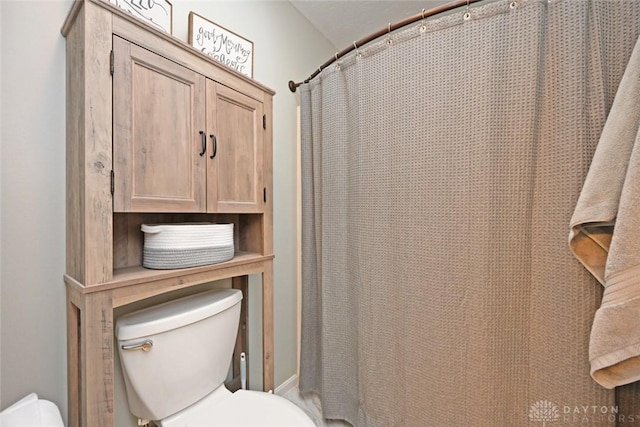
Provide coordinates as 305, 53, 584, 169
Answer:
262, 261, 274, 391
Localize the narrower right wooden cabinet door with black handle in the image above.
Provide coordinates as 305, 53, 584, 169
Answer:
207, 80, 264, 213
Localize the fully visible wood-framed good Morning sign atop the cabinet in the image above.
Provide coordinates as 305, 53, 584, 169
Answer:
189, 12, 253, 78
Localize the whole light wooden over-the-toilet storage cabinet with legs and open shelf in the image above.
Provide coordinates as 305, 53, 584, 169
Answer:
62, 0, 274, 427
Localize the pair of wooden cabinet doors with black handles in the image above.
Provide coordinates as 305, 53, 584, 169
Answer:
113, 36, 266, 213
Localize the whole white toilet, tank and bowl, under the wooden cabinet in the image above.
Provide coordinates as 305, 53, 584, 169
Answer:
116, 289, 315, 427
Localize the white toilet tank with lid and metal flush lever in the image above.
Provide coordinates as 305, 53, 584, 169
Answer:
116, 289, 242, 420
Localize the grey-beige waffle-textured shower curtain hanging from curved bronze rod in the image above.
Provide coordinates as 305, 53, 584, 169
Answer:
300, 0, 640, 427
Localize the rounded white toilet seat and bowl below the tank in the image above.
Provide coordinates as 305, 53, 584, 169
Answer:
159, 386, 315, 427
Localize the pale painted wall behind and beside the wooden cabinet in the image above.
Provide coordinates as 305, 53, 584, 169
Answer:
0, 0, 336, 424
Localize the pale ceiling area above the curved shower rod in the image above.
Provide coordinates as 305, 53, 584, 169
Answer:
290, 0, 452, 51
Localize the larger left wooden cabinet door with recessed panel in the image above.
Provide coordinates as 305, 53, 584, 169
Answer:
113, 36, 207, 212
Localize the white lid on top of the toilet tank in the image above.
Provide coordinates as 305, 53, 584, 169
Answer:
116, 289, 242, 340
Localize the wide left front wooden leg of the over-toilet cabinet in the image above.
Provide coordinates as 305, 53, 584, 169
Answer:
80, 292, 114, 427
